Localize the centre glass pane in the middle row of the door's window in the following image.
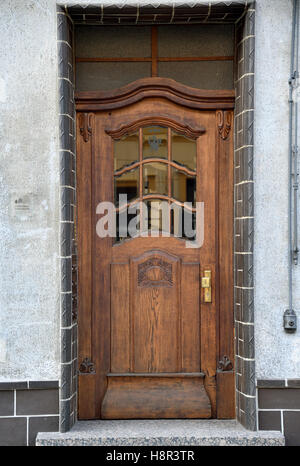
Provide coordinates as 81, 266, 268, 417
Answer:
143, 163, 168, 196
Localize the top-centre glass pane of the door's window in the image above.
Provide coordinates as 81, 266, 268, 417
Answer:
143, 126, 168, 159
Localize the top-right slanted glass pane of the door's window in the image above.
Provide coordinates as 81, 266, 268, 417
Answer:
172, 131, 197, 170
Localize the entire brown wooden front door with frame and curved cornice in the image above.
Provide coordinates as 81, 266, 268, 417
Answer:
77, 78, 234, 419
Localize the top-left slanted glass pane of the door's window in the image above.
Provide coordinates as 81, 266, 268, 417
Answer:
114, 131, 139, 171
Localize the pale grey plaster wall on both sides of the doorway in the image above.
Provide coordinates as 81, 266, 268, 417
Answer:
0, 0, 300, 380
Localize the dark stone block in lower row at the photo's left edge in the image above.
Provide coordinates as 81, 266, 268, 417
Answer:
0, 417, 27, 447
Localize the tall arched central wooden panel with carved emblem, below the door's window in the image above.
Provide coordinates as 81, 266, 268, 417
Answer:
130, 251, 181, 372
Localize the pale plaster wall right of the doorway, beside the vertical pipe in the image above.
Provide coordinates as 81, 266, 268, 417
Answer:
254, 0, 300, 379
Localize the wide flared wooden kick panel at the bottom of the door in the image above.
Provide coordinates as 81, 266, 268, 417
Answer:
102, 373, 211, 419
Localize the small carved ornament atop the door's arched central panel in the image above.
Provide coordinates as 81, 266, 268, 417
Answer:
138, 257, 173, 287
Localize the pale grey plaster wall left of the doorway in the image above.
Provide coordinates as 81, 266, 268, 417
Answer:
0, 0, 60, 380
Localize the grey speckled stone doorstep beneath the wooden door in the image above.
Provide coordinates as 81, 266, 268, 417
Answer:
36, 419, 285, 446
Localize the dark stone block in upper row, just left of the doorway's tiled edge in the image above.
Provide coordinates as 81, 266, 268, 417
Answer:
16, 388, 59, 415
